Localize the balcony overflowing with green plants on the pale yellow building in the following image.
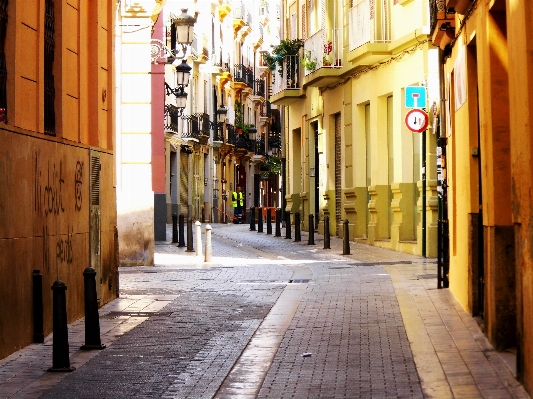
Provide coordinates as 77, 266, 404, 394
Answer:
270, 55, 305, 105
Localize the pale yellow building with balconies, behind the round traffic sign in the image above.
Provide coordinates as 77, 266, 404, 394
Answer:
271, 1, 439, 257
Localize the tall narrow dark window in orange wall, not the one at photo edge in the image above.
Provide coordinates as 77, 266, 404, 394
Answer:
44, 0, 56, 136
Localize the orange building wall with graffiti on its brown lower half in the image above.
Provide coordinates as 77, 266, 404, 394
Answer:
0, 0, 118, 358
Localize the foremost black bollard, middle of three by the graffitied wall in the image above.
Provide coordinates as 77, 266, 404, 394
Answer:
48, 280, 75, 371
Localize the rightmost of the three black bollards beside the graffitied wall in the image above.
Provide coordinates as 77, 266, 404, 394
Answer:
80, 267, 105, 350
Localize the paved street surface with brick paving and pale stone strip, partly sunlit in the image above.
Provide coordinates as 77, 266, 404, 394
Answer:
0, 224, 528, 398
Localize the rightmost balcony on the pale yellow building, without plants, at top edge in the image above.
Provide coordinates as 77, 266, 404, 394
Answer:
348, 0, 392, 65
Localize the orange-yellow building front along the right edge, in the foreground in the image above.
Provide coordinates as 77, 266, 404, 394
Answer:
432, 0, 533, 394
